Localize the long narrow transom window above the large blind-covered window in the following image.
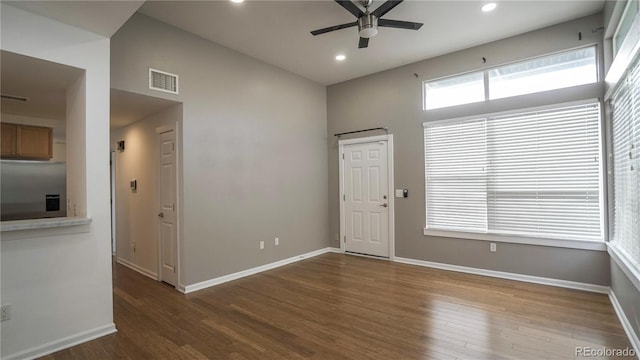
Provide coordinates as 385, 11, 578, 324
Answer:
424, 46, 598, 110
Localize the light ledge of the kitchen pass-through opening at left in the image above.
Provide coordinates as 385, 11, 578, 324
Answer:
0, 217, 91, 240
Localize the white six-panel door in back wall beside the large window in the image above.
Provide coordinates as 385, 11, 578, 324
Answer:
343, 140, 389, 257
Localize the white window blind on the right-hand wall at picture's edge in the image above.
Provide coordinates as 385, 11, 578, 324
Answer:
611, 52, 640, 269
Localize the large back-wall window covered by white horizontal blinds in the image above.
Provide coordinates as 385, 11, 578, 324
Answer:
424, 102, 603, 241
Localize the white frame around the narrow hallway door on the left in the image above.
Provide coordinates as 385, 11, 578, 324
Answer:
156, 122, 185, 292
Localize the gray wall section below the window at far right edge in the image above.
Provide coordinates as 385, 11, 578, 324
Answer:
611, 258, 640, 348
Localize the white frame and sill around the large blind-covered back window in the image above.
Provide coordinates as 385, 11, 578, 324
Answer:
422, 99, 608, 251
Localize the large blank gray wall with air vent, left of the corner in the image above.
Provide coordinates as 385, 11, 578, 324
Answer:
111, 14, 329, 285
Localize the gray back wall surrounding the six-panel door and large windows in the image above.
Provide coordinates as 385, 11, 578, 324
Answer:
327, 14, 609, 285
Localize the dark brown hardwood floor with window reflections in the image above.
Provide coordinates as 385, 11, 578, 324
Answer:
45, 254, 631, 360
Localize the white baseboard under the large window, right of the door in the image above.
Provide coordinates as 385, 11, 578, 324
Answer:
395, 257, 609, 294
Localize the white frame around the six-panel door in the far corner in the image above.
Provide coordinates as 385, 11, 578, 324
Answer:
338, 134, 396, 261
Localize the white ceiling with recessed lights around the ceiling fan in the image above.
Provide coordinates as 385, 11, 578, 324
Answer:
139, 0, 604, 85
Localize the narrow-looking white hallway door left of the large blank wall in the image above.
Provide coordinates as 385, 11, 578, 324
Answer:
158, 130, 178, 286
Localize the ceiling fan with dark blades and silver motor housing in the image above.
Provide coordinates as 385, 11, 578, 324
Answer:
311, 0, 423, 49
